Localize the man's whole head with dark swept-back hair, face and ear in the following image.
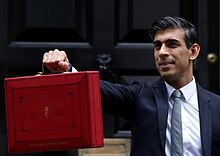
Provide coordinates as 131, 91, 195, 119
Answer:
149, 16, 200, 88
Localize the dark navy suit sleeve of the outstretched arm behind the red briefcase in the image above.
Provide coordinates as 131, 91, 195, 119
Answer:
100, 80, 145, 120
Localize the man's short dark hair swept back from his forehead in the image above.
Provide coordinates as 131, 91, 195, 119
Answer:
148, 16, 199, 49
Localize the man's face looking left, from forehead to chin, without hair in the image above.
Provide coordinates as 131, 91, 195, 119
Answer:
153, 29, 192, 83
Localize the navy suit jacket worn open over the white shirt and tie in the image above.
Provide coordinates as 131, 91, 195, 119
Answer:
101, 79, 220, 156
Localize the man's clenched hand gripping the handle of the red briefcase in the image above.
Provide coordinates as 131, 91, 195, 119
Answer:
43, 49, 69, 73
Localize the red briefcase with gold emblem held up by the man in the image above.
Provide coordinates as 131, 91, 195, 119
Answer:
5, 71, 103, 153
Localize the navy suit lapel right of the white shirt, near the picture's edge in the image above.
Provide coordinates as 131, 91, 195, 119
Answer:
198, 85, 212, 156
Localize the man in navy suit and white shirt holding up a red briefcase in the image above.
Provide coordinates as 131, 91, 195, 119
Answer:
43, 16, 220, 156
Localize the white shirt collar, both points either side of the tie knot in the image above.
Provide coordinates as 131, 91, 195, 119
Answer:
165, 77, 196, 101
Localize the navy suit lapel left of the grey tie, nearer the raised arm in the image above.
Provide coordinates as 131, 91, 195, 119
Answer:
150, 79, 169, 149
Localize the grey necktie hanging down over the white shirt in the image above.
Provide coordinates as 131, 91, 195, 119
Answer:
171, 90, 183, 156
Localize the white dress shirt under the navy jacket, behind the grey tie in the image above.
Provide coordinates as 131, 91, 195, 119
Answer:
165, 77, 202, 156
